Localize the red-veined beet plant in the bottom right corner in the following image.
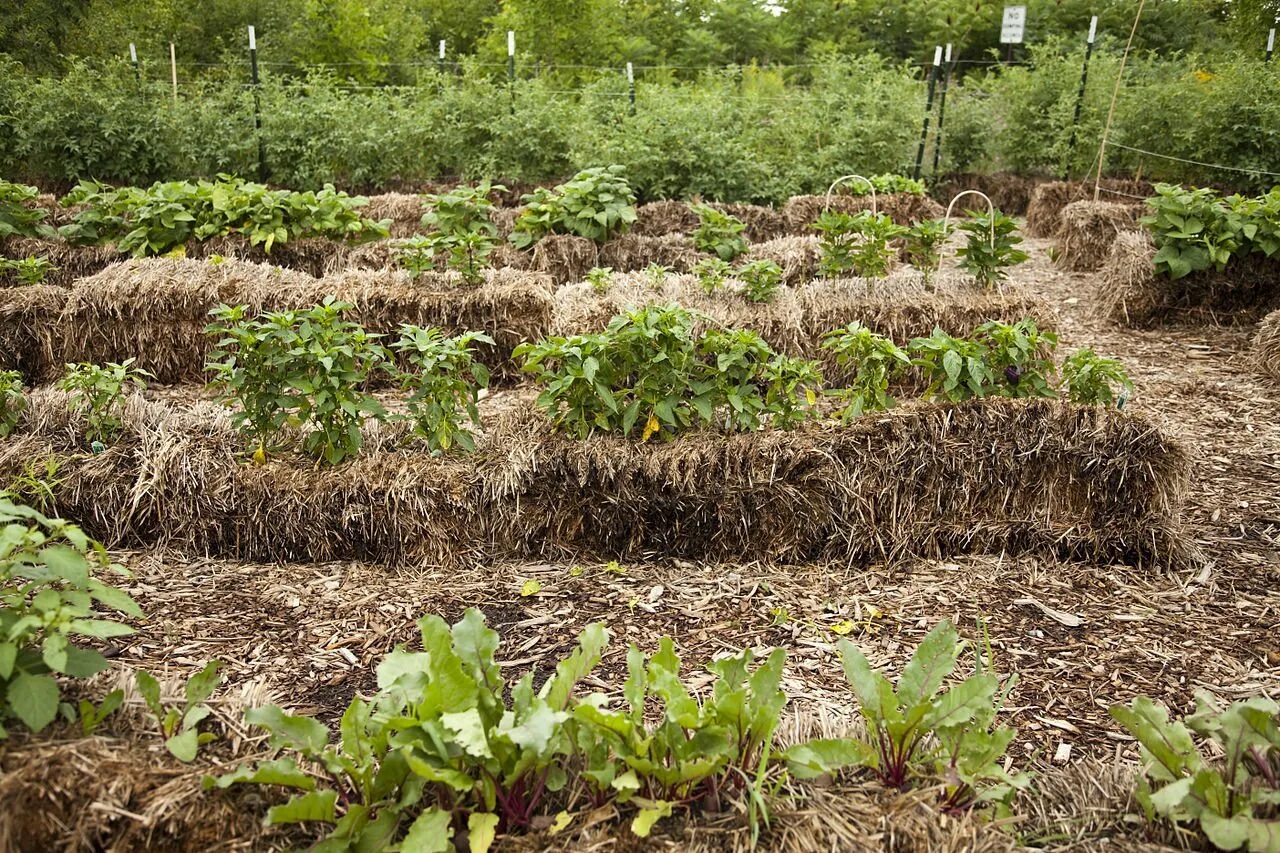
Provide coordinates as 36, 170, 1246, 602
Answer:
1111, 692, 1280, 853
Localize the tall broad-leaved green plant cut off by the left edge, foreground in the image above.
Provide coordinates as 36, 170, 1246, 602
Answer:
0, 496, 142, 738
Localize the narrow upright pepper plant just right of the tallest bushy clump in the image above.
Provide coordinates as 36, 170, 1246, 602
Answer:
392, 325, 493, 451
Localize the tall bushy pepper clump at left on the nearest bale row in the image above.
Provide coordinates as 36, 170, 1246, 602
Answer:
206, 297, 387, 465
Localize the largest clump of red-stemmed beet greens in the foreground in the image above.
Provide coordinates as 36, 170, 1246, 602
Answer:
205, 608, 608, 853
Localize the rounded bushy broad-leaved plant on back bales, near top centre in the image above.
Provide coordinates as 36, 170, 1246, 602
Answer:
511, 165, 636, 248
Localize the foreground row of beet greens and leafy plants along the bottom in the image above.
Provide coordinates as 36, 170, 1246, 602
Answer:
0, 498, 1280, 853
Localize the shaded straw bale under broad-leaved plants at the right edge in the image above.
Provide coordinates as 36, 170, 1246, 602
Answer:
1094, 231, 1280, 327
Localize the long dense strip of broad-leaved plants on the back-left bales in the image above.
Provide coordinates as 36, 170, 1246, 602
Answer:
61, 175, 388, 257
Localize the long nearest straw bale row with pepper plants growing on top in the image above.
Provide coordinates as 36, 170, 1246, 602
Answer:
0, 391, 1188, 566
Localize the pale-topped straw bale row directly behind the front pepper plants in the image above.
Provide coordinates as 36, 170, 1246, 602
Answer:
0, 256, 1053, 384
